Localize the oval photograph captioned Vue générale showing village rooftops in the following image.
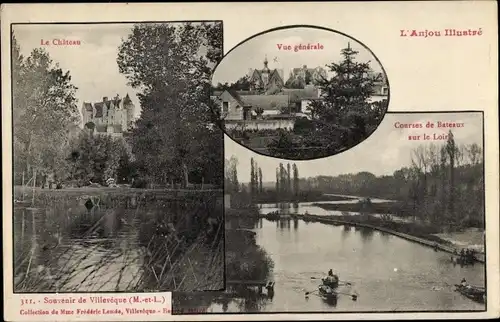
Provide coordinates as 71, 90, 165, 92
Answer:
211, 26, 389, 160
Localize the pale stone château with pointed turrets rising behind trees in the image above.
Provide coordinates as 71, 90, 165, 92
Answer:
82, 94, 135, 136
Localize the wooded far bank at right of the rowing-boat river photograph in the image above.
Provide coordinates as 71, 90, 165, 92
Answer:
300, 135, 484, 229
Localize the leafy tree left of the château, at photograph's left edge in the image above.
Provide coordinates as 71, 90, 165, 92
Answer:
12, 35, 80, 182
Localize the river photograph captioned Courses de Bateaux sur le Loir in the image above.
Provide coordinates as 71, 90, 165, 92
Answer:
173, 112, 486, 314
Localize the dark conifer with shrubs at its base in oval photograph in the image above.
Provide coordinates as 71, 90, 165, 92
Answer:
268, 46, 387, 159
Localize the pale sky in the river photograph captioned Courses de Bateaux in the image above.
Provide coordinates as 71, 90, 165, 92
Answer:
228, 112, 483, 182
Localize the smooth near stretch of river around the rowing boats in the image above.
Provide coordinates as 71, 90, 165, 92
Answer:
203, 219, 485, 312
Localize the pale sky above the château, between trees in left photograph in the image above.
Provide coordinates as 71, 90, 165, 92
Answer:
13, 24, 140, 121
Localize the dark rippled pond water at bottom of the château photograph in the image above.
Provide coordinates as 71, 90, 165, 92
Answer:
14, 195, 223, 292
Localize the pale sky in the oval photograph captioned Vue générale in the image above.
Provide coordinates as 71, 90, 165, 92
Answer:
212, 27, 381, 85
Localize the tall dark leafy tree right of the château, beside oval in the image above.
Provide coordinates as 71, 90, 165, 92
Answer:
117, 23, 224, 187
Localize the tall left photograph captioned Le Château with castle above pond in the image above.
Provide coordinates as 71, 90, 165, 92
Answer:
11, 21, 225, 293
